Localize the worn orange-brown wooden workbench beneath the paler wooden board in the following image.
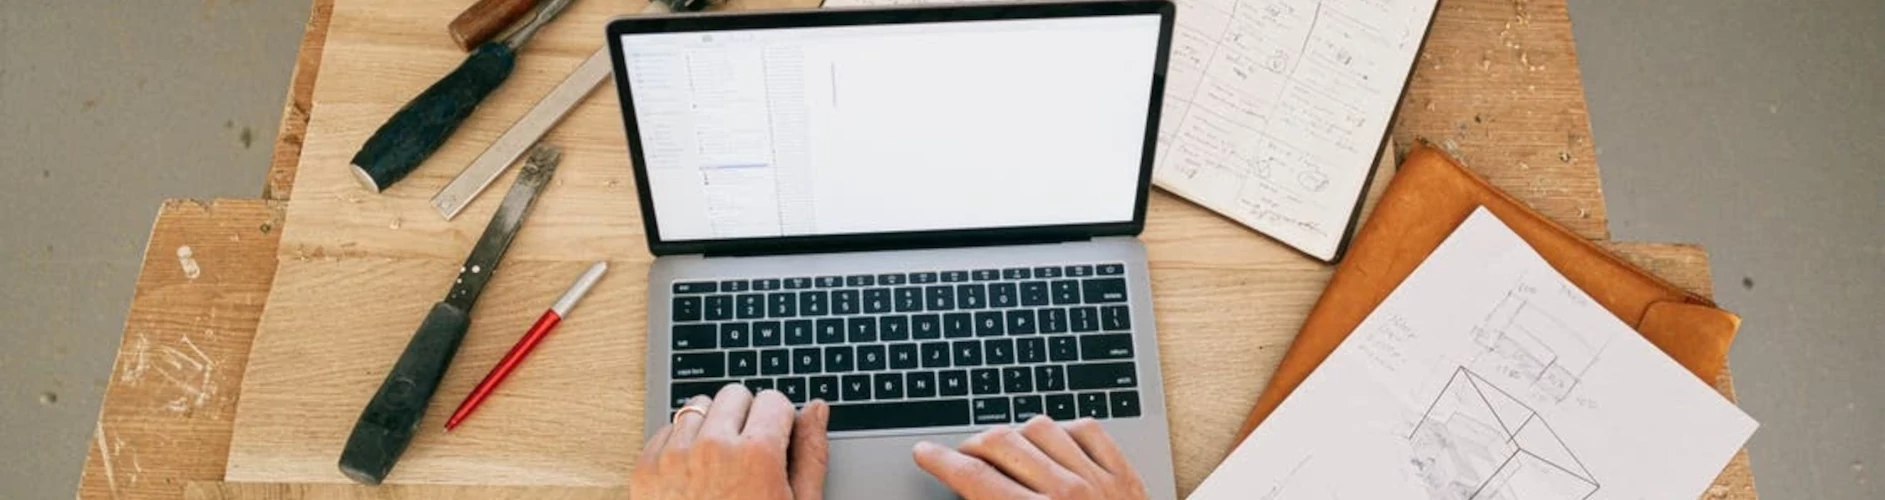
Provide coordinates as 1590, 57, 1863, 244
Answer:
79, 0, 1759, 500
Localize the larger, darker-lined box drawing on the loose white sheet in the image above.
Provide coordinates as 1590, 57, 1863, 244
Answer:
1408, 366, 1598, 500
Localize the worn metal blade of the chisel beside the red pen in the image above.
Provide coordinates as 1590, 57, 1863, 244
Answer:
445, 145, 562, 311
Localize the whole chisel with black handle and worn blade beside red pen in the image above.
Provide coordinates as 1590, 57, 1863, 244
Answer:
339, 145, 560, 485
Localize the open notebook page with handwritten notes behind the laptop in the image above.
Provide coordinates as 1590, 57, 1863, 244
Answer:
824, 0, 1436, 260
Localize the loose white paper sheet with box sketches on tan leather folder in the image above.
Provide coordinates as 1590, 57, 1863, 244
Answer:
1191, 208, 1757, 500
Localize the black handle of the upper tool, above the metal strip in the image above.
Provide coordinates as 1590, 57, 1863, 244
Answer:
352, 42, 516, 192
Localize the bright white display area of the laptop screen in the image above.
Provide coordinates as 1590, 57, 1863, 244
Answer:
622, 15, 1159, 242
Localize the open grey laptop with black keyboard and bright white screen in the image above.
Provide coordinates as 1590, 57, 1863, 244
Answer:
609, 2, 1176, 500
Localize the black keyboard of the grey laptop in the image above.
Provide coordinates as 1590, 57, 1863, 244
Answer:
669, 264, 1140, 430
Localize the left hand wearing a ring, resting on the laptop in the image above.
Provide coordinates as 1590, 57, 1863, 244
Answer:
628, 383, 831, 500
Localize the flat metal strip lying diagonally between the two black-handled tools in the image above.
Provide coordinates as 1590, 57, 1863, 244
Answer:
432, 0, 724, 221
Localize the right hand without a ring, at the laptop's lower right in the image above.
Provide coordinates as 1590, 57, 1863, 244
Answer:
914, 415, 1146, 500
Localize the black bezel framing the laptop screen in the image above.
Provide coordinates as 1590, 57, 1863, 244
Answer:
607, 0, 1176, 255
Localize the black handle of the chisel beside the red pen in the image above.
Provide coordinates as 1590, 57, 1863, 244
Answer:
339, 302, 471, 485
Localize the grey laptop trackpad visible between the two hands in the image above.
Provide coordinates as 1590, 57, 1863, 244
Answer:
826, 432, 975, 500
